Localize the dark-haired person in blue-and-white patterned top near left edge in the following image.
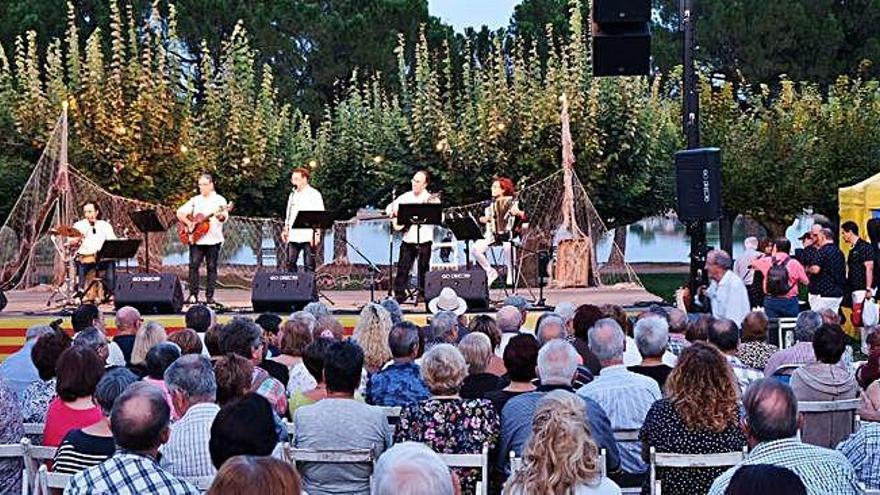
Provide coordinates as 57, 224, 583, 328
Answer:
21, 330, 70, 423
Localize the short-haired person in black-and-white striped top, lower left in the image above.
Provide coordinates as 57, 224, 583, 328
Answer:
53, 368, 138, 474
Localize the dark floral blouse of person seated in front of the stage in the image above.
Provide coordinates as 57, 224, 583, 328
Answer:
394, 397, 501, 495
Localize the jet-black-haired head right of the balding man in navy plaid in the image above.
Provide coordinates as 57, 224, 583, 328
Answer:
208, 393, 278, 470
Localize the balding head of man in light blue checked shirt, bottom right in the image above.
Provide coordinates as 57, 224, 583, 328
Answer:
743, 378, 798, 442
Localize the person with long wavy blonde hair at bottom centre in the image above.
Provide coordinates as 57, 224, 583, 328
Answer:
504, 390, 620, 495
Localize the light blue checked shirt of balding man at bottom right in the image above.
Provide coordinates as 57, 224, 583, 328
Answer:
709, 438, 861, 495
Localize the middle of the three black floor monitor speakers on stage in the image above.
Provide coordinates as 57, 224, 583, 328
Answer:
251, 272, 318, 313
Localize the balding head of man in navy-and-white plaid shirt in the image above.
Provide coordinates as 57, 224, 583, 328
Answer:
110, 382, 171, 452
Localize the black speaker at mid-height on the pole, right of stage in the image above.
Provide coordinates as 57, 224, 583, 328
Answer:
675, 148, 722, 221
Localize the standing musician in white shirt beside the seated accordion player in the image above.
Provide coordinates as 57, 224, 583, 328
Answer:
385, 170, 439, 304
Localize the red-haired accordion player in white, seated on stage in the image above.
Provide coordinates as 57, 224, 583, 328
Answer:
474, 177, 525, 287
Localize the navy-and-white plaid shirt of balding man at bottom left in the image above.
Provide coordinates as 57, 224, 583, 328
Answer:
64, 451, 199, 495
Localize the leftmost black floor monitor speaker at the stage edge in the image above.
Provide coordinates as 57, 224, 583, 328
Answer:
113, 273, 183, 314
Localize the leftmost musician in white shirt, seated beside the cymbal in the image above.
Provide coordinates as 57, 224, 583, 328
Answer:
71, 201, 116, 291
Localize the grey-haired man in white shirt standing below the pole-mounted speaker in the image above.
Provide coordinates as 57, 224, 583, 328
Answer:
706, 249, 752, 325
